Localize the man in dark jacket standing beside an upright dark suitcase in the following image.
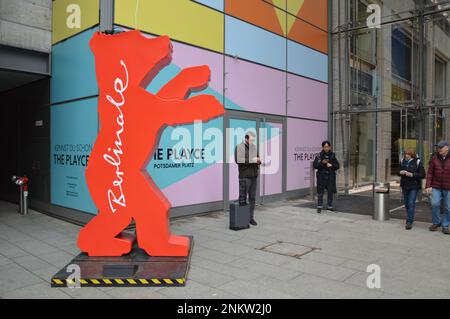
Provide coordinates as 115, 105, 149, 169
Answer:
234, 131, 261, 226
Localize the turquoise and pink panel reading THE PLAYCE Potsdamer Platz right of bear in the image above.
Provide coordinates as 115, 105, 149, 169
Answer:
147, 118, 223, 207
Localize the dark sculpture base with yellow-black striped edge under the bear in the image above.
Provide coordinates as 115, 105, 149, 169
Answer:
51, 236, 194, 288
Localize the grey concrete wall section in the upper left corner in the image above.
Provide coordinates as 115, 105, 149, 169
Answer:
0, 0, 52, 53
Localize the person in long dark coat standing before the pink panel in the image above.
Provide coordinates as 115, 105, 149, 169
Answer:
313, 141, 339, 214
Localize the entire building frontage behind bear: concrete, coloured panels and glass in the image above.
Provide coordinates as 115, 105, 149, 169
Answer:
0, 0, 450, 223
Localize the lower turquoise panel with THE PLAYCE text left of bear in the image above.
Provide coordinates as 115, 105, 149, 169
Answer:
50, 98, 98, 214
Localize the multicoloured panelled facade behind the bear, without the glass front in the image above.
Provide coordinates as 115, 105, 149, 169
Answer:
0, 0, 329, 222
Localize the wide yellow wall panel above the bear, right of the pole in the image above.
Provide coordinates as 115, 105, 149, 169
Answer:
114, 0, 224, 52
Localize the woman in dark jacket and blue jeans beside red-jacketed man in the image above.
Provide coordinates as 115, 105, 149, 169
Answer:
399, 149, 425, 230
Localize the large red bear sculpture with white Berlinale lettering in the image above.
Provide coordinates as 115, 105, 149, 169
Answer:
78, 31, 224, 256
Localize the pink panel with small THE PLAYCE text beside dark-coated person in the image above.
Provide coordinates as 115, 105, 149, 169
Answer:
285, 118, 327, 191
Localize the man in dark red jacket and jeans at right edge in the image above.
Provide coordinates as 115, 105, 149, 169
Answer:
426, 141, 450, 235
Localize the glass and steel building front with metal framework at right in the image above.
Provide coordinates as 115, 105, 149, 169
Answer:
330, 0, 450, 192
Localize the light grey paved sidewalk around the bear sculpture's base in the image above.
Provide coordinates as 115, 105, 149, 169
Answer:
0, 200, 450, 298
